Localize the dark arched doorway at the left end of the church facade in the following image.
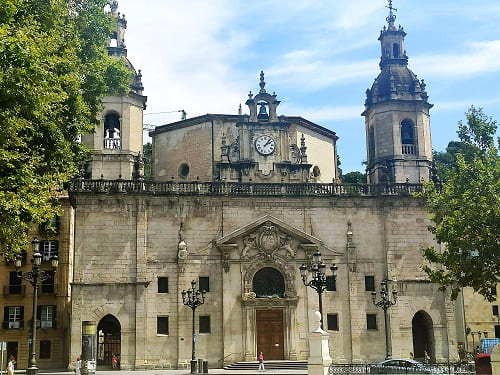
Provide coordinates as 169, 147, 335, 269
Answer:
97, 315, 121, 368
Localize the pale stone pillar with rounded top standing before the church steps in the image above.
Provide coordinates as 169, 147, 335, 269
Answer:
307, 311, 332, 375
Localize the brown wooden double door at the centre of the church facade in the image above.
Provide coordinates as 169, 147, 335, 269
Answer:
256, 310, 285, 360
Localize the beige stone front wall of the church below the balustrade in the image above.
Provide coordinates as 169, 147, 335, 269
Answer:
72, 194, 456, 368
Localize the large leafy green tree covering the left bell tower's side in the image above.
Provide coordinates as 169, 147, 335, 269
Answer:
0, 0, 131, 253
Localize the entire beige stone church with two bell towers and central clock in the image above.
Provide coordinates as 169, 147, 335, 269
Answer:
69, 1, 459, 369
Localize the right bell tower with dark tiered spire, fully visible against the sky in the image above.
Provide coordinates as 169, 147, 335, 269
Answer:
362, 0, 432, 184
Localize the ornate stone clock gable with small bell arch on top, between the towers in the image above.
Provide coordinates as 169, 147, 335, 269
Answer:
218, 72, 311, 182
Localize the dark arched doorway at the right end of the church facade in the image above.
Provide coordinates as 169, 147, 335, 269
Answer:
411, 310, 436, 362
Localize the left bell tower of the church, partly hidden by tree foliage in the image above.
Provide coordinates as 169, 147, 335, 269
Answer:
83, 0, 147, 180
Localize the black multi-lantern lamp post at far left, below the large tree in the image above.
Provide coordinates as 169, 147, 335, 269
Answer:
14, 237, 59, 375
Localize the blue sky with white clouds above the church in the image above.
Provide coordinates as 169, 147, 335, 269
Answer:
113, 0, 500, 173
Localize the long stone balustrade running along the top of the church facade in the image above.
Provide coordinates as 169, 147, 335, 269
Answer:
69, 179, 423, 197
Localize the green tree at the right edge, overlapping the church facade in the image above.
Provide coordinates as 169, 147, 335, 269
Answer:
423, 107, 500, 301
